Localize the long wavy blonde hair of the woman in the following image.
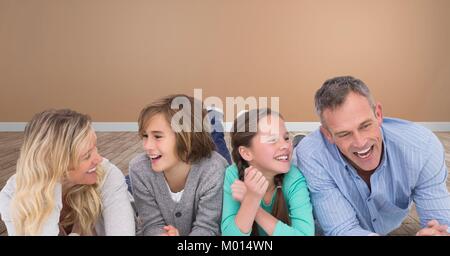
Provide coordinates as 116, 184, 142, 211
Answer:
11, 109, 104, 235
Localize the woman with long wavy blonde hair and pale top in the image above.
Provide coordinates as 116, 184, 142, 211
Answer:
0, 110, 135, 235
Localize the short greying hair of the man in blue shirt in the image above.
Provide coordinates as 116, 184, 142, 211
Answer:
314, 76, 375, 124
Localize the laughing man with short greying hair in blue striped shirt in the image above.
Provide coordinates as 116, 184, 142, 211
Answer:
293, 76, 450, 235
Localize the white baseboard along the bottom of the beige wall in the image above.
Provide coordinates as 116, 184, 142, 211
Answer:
0, 122, 450, 132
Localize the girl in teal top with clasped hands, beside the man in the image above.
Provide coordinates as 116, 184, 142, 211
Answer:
221, 109, 314, 236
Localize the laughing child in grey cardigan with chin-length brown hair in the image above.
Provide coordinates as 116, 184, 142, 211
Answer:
129, 95, 227, 236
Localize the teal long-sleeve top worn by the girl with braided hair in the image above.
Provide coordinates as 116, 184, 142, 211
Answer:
221, 164, 314, 236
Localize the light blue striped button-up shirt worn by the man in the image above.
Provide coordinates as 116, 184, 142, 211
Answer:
293, 118, 450, 235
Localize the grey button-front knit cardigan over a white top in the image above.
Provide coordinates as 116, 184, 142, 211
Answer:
129, 152, 228, 236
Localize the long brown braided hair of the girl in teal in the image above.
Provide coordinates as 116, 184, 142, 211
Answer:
231, 108, 291, 236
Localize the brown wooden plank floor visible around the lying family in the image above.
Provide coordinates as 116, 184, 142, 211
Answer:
0, 132, 450, 235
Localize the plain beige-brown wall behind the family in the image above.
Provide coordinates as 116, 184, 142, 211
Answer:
0, 0, 450, 122
